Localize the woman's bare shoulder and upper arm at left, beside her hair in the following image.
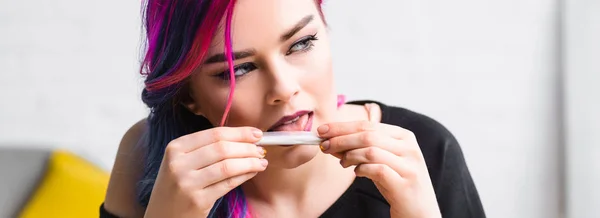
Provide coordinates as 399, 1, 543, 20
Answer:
104, 119, 146, 217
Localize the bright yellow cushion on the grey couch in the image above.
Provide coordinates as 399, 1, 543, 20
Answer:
20, 151, 109, 218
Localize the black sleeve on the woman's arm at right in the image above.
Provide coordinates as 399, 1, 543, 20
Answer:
388, 108, 486, 218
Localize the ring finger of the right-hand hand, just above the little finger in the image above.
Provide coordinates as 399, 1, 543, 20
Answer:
340, 147, 417, 179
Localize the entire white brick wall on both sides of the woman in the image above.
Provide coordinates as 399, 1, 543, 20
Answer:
0, 0, 572, 218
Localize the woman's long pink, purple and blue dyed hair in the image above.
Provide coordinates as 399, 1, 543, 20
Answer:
138, 0, 323, 218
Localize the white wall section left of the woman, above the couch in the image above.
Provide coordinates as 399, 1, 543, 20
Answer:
0, 0, 144, 168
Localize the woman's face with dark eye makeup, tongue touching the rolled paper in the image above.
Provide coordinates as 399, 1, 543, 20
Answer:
188, 0, 337, 168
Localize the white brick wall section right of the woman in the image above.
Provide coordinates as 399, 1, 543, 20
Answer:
328, 0, 560, 218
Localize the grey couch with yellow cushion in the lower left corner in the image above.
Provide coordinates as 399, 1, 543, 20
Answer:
0, 147, 109, 218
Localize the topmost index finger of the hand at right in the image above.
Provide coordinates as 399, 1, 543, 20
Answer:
317, 121, 414, 139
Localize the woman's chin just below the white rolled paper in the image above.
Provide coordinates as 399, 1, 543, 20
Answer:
267, 145, 321, 169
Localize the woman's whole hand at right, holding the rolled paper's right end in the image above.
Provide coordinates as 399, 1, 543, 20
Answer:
317, 121, 441, 218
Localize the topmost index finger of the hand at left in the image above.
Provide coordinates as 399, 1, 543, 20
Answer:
170, 127, 262, 153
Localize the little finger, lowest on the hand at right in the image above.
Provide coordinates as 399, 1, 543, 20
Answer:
354, 163, 404, 187
